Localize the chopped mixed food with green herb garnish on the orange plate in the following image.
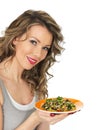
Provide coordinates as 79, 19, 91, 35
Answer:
41, 96, 76, 112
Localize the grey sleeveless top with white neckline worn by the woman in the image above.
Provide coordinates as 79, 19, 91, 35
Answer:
0, 80, 37, 130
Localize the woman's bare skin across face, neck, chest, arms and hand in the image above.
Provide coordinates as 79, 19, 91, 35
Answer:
0, 25, 68, 130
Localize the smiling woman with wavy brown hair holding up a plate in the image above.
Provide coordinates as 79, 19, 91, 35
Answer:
0, 10, 71, 130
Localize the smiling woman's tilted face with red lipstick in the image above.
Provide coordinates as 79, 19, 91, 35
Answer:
13, 25, 53, 70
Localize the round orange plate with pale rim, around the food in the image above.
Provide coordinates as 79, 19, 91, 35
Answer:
35, 97, 83, 114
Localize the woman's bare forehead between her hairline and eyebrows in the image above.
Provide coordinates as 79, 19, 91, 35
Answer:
27, 25, 53, 44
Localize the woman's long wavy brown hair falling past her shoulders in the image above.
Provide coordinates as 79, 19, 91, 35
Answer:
0, 10, 64, 99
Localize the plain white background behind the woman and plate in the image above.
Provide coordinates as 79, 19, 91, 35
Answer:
0, 0, 98, 130
